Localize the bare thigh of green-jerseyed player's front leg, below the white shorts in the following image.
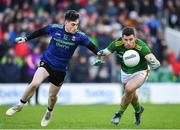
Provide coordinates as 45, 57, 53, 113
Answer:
125, 74, 145, 91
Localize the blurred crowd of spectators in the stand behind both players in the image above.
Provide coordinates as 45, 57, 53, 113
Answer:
0, 0, 180, 83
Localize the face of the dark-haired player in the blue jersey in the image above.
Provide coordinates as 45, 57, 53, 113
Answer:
65, 20, 79, 33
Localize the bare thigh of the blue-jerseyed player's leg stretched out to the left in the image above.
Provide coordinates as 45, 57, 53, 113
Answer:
31, 67, 49, 84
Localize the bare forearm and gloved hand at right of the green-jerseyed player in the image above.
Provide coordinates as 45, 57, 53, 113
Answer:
145, 53, 161, 69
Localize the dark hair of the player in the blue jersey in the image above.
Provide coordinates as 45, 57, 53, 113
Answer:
65, 10, 79, 21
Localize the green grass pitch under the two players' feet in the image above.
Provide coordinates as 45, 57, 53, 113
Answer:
0, 104, 180, 129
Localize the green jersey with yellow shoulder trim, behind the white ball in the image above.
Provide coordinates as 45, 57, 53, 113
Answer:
107, 38, 151, 74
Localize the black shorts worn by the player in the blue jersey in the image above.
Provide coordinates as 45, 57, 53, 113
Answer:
39, 61, 66, 86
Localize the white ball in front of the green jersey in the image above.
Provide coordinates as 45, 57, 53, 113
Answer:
123, 50, 140, 67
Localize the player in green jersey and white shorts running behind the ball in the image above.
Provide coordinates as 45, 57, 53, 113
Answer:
94, 27, 160, 125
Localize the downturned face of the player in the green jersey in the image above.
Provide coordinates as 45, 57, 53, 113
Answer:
122, 35, 136, 49
